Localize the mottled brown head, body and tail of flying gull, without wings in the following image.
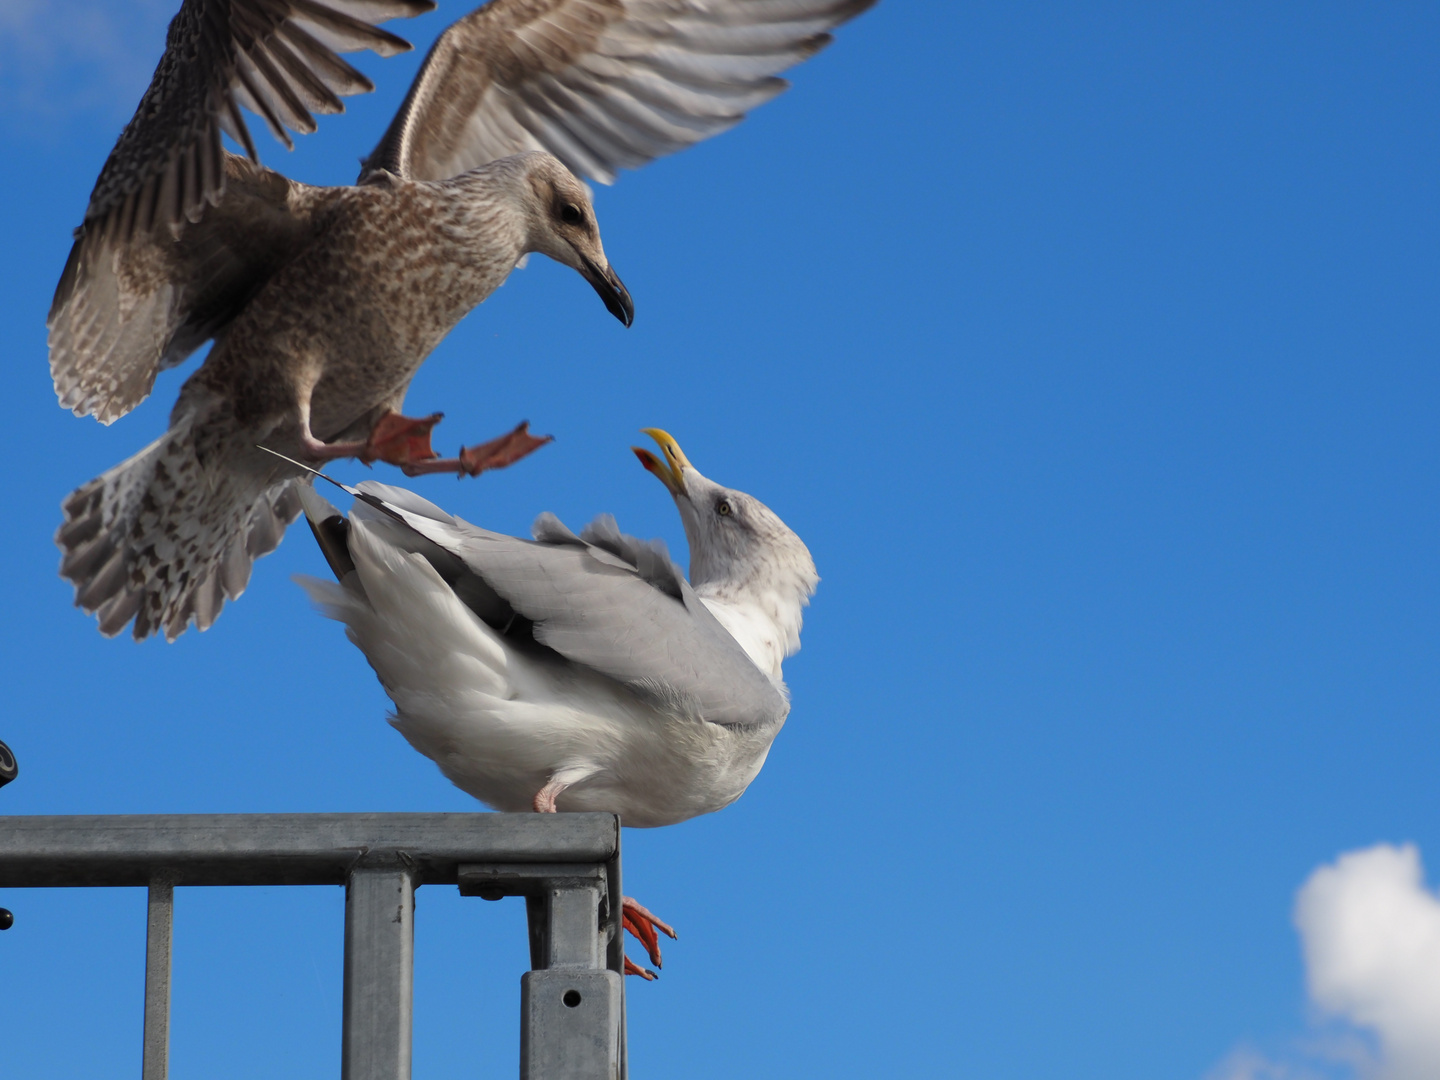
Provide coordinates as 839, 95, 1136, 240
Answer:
56, 153, 624, 638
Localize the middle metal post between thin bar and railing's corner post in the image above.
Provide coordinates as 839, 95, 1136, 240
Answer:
340, 865, 415, 1080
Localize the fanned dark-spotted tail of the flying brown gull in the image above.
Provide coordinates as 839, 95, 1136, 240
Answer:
55, 419, 301, 641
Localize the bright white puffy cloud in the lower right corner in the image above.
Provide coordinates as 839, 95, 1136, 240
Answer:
1295, 844, 1440, 1080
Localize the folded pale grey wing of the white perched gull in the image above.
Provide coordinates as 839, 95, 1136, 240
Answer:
351, 482, 789, 724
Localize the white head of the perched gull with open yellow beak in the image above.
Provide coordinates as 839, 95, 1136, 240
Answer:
632, 428, 819, 633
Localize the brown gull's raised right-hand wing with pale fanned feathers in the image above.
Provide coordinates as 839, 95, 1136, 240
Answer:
366, 0, 874, 183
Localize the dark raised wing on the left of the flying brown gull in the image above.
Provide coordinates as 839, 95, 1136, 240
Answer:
46, 0, 435, 423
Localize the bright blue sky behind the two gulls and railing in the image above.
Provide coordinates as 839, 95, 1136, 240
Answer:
0, 0, 1440, 1080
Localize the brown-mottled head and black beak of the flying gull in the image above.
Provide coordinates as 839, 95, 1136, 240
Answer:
518, 151, 635, 325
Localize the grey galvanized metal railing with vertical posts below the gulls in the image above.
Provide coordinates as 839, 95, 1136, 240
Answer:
0, 814, 626, 1080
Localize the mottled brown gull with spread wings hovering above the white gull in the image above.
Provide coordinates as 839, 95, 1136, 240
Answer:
48, 0, 874, 639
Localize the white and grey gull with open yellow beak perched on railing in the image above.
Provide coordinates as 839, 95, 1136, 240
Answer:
297, 429, 819, 973
